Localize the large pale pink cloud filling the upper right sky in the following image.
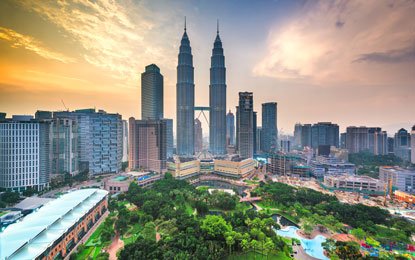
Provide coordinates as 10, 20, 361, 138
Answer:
253, 0, 415, 85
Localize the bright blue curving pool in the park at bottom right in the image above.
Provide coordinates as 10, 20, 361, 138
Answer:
275, 226, 328, 260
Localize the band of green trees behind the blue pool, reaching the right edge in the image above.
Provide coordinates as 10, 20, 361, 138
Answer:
255, 182, 415, 244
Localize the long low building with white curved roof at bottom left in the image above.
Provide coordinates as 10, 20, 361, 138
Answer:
0, 189, 108, 259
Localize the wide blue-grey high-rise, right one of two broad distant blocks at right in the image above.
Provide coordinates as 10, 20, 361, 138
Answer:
346, 126, 387, 155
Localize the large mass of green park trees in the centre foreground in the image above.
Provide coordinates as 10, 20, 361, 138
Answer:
115, 175, 289, 259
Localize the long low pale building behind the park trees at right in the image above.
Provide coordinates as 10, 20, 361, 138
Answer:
324, 174, 384, 192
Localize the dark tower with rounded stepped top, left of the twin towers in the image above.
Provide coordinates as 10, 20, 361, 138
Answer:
141, 64, 163, 120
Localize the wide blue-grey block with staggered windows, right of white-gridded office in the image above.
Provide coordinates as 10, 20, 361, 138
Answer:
53, 109, 123, 174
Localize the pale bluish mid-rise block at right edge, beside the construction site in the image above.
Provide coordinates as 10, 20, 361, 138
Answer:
379, 166, 415, 194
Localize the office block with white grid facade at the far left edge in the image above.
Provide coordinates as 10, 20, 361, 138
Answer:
0, 116, 52, 191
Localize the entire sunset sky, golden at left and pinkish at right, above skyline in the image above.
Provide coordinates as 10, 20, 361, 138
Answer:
0, 0, 415, 135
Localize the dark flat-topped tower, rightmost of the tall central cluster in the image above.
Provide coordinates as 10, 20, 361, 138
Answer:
261, 102, 278, 153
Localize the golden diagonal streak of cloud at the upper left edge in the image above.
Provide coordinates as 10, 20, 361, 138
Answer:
0, 27, 75, 63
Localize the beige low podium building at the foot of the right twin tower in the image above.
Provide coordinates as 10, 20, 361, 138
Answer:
214, 157, 256, 178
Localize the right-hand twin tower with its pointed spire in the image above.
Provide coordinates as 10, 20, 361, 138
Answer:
209, 23, 226, 154
